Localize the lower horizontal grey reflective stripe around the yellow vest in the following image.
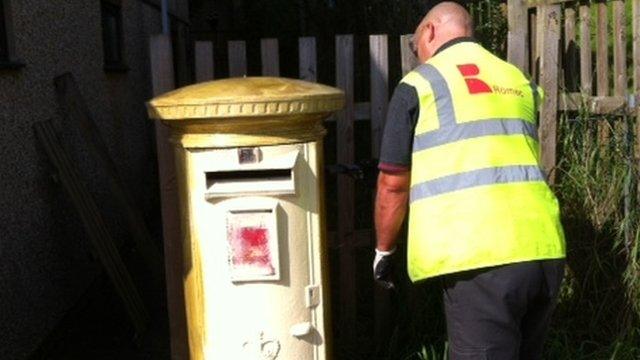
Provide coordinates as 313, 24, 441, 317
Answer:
410, 165, 545, 202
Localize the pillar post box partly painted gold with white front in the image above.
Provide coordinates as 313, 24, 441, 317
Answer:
148, 77, 344, 360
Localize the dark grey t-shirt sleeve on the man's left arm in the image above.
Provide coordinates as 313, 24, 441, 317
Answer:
378, 83, 420, 171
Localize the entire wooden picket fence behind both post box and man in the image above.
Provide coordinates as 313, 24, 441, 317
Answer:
155, 0, 640, 354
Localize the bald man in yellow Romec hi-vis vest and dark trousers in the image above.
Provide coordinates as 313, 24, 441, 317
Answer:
374, 2, 565, 360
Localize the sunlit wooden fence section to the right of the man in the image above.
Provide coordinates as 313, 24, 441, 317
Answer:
507, 0, 640, 177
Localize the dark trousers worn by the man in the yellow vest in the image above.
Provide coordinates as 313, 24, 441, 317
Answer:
443, 260, 564, 360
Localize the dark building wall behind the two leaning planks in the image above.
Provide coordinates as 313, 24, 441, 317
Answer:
0, 0, 188, 359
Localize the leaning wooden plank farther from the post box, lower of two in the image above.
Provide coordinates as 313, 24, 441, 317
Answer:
34, 121, 149, 335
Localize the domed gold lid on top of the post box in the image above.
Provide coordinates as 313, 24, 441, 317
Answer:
147, 77, 344, 120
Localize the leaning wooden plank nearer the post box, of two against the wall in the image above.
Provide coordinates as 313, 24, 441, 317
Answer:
53, 73, 162, 282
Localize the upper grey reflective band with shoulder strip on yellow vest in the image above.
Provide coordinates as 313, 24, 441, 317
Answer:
413, 64, 538, 152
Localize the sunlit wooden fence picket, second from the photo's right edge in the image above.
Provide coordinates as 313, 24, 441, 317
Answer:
611, 0, 627, 96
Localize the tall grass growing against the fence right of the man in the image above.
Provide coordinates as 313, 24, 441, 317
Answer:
546, 112, 640, 359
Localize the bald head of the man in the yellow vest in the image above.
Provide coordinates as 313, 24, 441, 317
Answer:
413, 1, 473, 62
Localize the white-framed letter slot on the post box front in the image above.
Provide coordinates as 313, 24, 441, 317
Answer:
205, 151, 298, 199
